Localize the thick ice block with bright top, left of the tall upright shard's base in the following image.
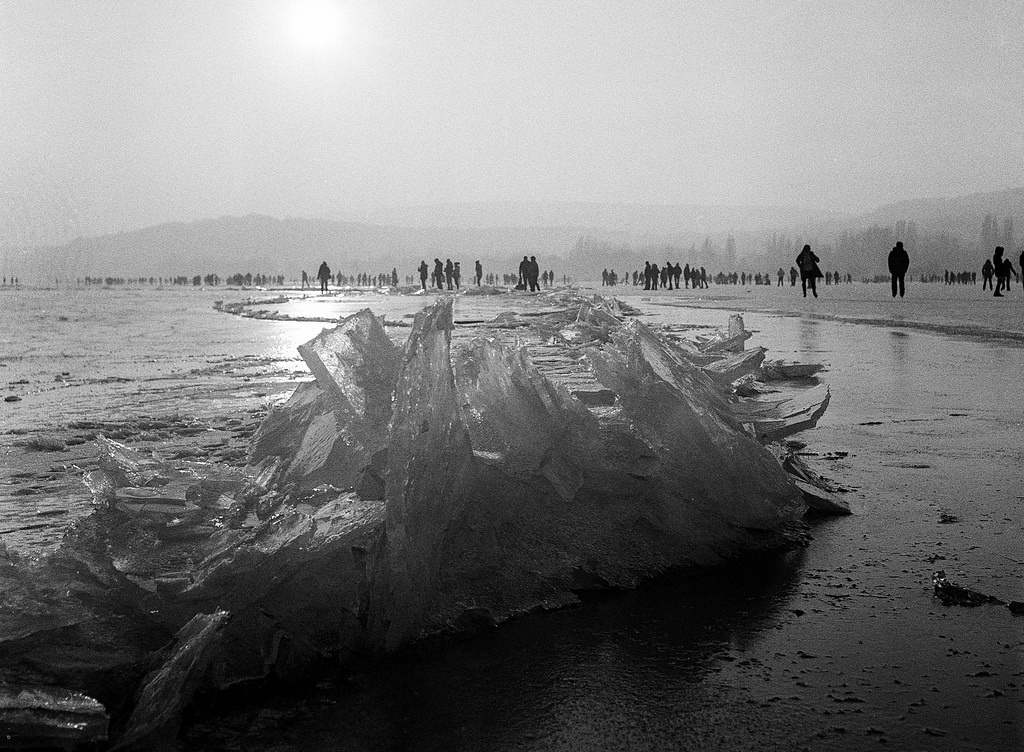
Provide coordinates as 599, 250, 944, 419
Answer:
176, 494, 384, 682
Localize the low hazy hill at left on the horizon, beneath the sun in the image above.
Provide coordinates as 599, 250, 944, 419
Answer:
3, 215, 577, 280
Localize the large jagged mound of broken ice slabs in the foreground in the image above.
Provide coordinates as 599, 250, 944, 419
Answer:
0, 290, 848, 747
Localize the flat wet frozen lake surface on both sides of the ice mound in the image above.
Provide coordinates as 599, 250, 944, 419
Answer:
0, 285, 1024, 750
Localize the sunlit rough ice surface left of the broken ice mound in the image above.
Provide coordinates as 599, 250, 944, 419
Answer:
0, 289, 323, 550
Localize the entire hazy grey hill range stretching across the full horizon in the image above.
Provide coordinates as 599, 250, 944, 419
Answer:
8, 187, 1024, 280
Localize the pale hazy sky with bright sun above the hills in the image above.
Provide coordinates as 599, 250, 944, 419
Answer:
0, 0, 1024, 242
